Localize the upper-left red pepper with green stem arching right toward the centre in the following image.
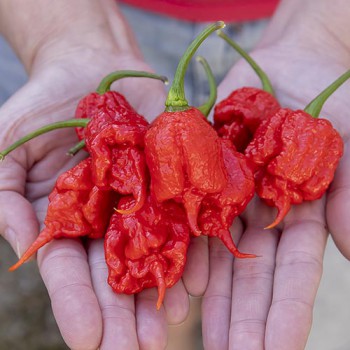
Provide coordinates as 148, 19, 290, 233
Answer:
76, 71, 166, 211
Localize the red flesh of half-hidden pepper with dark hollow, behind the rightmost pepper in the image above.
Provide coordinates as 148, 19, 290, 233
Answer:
213, 87, 281, 152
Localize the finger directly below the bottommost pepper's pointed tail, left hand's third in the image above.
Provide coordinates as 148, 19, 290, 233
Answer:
136, 288, 168, 350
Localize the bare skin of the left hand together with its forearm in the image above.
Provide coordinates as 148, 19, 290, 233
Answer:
0, 0, 208, 350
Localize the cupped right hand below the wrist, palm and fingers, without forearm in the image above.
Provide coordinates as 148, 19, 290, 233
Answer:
202, 33, 350, 350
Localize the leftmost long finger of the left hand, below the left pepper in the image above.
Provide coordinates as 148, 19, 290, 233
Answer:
38, 239, 102, 350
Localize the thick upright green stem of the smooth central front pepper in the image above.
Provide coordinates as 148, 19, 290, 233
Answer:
165, 21, 225, 112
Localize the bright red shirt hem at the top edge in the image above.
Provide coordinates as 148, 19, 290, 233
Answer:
121, 0, 279, 22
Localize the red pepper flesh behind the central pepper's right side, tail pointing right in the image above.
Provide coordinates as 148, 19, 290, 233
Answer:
198, 140, 256, 258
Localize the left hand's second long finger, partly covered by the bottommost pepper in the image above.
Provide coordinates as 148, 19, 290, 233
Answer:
89, 240, 138, 350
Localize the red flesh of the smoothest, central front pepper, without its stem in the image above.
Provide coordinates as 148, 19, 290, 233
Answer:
145, 107, 227, 235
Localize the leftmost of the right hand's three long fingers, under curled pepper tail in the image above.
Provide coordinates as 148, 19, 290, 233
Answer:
202, 220, 242, 350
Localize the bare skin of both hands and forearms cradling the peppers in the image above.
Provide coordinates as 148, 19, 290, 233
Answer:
0, 0, 350, 350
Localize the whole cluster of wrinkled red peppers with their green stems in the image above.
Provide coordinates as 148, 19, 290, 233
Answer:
0, 22, 350, 309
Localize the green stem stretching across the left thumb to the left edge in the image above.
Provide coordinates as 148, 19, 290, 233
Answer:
0, 118, 90, 160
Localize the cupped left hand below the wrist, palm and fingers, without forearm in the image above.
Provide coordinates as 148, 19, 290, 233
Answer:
0, 48, 208, 350
